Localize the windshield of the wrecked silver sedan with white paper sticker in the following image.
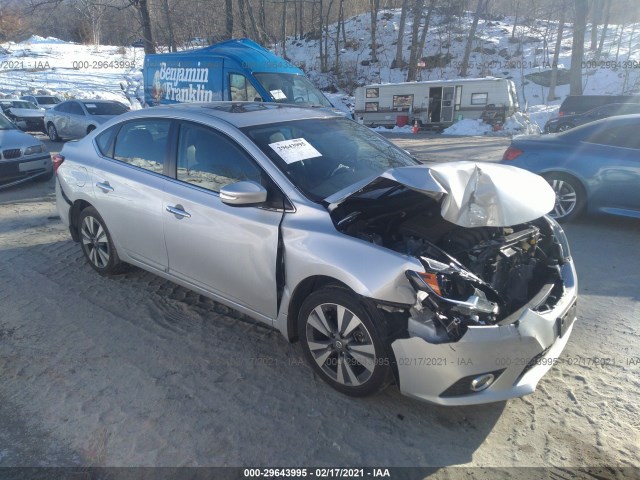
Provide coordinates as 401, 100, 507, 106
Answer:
242, 118, 418, 202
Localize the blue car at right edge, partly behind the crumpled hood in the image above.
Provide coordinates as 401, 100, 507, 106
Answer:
502, 115, 640, 221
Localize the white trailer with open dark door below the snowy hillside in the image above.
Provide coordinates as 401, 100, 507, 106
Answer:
354, 77, 518, 129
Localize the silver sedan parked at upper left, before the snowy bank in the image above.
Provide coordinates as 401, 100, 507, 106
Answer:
44, 100, 129, 142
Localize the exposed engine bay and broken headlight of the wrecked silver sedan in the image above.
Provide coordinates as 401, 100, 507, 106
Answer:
332, 186, 564, 343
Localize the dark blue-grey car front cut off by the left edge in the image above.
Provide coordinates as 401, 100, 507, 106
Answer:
0, 114, 53, 188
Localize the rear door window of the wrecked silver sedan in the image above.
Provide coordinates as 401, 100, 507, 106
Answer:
112, 119, 171, 173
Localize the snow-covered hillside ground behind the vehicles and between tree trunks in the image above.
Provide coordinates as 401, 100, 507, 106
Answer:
0, 9, 640, 134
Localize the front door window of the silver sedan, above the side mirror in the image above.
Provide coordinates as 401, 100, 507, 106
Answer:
177, 123, 265, 192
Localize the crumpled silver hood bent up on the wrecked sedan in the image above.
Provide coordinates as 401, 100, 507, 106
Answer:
325, 162, 555, 227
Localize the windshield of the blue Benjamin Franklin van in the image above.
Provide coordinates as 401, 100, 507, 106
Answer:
254, 73, 332, 107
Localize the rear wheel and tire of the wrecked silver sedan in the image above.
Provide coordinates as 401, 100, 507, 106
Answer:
78, 207, 124, 275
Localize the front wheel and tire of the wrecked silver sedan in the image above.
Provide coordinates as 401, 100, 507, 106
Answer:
298, 287, 392, 397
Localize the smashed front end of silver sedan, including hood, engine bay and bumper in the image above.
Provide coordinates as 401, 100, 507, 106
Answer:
331, 163, 577, 405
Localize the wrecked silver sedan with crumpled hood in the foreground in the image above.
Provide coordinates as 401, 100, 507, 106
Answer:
56, 103, 577, 405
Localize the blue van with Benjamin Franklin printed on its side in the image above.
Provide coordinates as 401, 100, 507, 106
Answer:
143, 38, 341, 113
